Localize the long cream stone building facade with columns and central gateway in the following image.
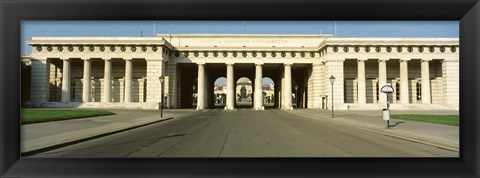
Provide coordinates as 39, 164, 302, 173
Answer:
22, 34, 459, 110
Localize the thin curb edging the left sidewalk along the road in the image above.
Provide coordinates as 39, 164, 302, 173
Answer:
21, 117, 173, 157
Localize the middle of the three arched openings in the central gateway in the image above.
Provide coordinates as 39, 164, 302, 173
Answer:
235, 77, 253, 108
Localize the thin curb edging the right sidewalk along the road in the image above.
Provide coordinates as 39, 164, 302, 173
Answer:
289, 112, 460, 152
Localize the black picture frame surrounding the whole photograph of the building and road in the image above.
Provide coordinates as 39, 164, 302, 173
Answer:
0, 0, 480, 177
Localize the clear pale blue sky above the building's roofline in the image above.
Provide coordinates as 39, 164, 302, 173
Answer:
21, 21, 459, 85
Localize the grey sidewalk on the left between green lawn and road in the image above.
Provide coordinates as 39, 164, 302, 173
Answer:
20, 109, 189, 155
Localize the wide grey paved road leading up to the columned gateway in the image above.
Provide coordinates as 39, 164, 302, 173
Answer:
32, 109, 459, 158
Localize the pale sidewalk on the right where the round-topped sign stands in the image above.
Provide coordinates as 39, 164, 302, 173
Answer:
289, 109, 460, 151
